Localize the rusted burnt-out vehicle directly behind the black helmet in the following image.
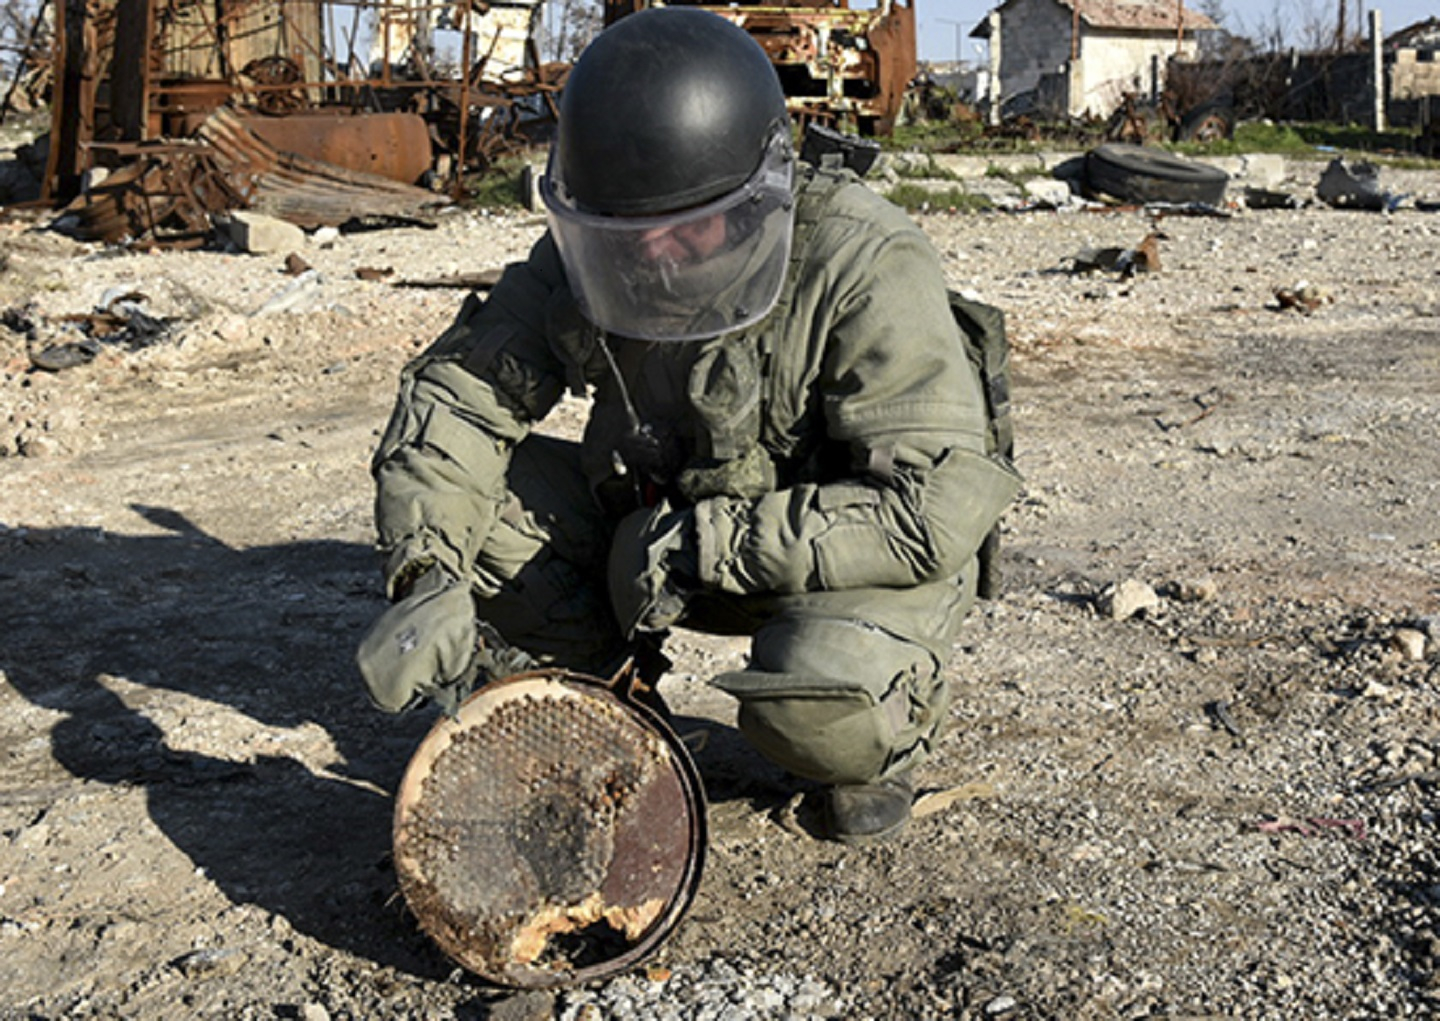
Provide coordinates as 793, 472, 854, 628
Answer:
605, 0, 917, 135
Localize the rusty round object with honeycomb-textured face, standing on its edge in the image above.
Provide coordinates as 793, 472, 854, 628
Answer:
395, 670, 706, 988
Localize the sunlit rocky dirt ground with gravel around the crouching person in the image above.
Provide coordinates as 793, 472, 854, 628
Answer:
0, 137, 1440, 1021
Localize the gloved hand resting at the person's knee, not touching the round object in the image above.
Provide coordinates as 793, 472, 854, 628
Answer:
609, 500, 700, 638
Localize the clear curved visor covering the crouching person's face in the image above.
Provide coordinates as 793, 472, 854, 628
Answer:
540, 135, 795, 340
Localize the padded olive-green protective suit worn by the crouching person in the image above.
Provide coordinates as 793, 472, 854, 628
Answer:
373, 167, 1020, 783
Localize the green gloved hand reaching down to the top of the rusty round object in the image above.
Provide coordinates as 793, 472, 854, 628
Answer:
356, 566, 478, 713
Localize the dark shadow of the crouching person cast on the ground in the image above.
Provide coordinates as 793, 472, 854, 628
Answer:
0, 507, 472, 979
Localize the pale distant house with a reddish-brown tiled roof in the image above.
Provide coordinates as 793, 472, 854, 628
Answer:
971, 0, 1218, 117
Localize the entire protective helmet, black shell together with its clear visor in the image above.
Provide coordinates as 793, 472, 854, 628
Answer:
541, 7, 795, 340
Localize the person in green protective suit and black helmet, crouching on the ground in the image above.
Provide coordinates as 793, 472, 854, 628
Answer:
359, 7, 1018, 842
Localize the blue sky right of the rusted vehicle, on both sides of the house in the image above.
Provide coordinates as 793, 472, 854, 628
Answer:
915, 0, 1440, 60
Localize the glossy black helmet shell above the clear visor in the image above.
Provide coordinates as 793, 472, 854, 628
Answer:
557, 7, 789, 216
